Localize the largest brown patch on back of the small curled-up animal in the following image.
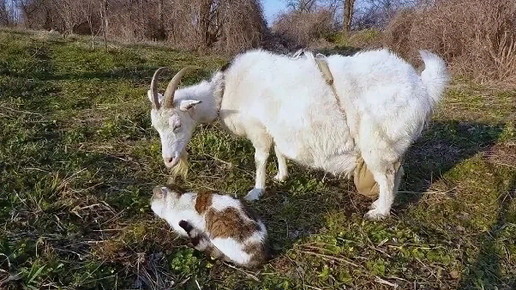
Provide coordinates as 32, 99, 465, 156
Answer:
206, 207, 260, 242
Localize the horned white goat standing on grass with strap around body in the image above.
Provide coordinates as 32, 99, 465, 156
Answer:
148, 49, 449, 219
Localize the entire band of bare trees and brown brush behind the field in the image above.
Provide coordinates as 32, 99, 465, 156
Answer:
0, 0, 516, 84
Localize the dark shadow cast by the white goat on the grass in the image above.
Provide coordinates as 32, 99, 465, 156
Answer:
191, 121, 503, 255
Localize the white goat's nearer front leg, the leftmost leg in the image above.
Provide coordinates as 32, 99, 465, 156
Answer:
244, 132, 272, 201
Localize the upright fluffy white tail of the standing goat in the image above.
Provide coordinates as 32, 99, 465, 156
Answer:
419, 50, 450, 104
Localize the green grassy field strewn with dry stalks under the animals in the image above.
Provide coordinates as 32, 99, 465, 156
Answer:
0, 31, 516, 289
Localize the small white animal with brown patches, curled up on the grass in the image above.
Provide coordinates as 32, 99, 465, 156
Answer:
151, 186, 269, 268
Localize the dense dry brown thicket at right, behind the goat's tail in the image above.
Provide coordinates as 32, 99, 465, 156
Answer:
383, 0, 516, 86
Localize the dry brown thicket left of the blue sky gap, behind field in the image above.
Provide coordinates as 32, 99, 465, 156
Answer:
15, 0, 266, 53
